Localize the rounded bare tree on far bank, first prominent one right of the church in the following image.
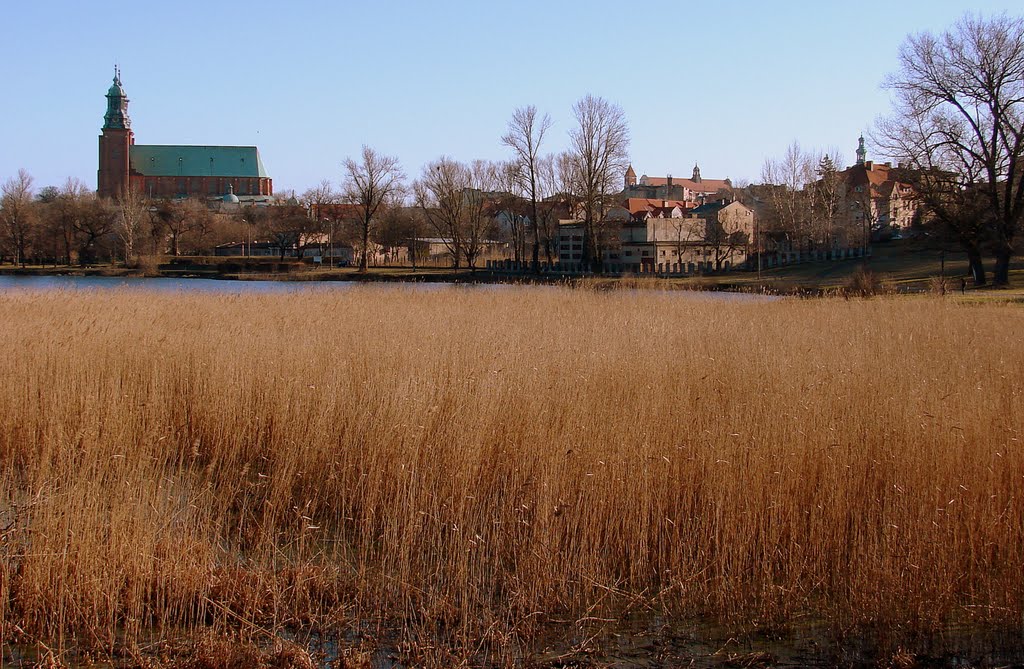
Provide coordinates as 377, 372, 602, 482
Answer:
344, 145, 406, 271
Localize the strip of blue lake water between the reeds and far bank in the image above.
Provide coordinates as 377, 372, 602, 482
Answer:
0, 275, 778, 301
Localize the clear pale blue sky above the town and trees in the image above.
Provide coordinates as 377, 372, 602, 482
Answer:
0, 0, 1021, 193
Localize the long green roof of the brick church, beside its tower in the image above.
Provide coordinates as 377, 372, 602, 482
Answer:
129, 144, 267, 177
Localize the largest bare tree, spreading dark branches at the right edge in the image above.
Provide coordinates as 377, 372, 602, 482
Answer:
876, 14, 1024, 285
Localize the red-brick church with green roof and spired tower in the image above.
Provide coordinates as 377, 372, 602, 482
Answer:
96, 70, 273, 200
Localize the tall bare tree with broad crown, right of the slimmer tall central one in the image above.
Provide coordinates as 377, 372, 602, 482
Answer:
566, 95, 630, 267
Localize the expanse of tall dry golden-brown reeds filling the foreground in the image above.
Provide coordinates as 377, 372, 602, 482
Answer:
0, 287, 1024, 666
